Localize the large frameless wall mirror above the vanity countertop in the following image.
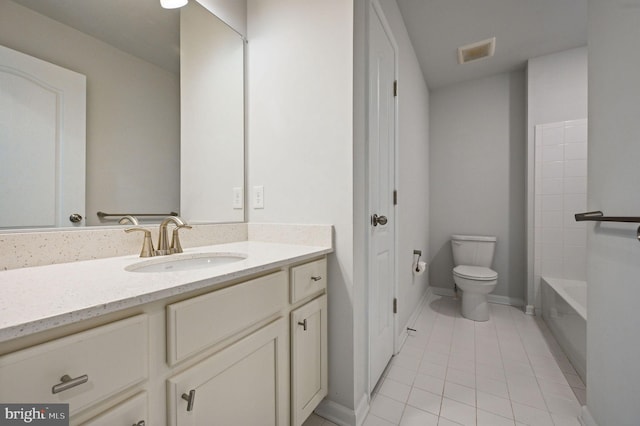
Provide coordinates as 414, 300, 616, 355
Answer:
0, 0, 245, 230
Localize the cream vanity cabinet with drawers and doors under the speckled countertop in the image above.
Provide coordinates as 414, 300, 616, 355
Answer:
0, 255, 327, 426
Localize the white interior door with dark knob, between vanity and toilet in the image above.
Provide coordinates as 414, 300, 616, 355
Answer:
368, 5, 395, 391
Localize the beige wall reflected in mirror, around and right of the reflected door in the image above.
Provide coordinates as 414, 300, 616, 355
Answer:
0, 1, 180, 224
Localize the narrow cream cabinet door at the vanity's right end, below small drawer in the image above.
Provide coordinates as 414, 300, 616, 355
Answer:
291, 295, 327, 426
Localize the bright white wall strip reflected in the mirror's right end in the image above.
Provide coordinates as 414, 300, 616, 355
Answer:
180, 2, 245, 224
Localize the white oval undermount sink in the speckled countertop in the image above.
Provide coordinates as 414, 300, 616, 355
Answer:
124, 253, 247, 272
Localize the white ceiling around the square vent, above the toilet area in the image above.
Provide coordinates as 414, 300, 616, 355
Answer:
397, 0, 588, 89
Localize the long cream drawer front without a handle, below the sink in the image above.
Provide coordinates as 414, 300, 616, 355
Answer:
167, 271, 287, 365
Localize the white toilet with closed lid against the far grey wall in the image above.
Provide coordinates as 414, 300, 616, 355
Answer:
451, 235, 498, 321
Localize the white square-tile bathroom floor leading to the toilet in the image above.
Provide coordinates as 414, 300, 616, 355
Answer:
304, 297, 586, 426
